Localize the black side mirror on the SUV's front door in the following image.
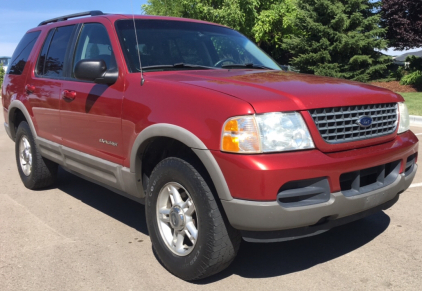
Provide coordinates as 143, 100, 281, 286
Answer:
75, 59, 119, 85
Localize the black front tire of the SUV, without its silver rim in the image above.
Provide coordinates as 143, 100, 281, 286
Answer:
145, 158, 241, 281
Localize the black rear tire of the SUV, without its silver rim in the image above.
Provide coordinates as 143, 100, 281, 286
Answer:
15, 121, 58, 190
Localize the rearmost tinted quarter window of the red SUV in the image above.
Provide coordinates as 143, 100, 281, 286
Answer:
7, 31, 40, 75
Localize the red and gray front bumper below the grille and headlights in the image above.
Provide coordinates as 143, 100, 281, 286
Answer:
218, 131, 418, 242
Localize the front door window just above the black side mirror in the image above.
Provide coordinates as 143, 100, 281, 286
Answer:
73, 23, 116, 74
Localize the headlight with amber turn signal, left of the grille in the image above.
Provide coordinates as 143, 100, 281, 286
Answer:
221, 112, 315, 153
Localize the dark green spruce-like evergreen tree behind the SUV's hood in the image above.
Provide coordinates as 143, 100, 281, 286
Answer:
284, 0, 391, 82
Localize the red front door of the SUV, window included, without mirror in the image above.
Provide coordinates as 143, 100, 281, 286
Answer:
60, 20, 124, 164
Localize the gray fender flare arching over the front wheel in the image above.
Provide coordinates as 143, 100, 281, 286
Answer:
130, 123, 233, 200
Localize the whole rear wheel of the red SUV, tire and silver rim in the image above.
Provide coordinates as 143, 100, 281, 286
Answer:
15, 121, 58, 190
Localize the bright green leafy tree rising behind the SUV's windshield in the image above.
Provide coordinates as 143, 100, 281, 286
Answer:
142, 0, 297, 62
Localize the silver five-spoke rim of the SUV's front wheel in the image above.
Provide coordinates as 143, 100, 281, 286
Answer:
157, 182, 198, 256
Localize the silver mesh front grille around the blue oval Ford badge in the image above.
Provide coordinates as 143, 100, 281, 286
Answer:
309, 103, 397, 144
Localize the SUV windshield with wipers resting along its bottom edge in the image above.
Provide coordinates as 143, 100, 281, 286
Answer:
116, 19, 280, 72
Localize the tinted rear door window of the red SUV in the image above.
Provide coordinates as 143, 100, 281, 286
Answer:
37, 25, 75, 78
